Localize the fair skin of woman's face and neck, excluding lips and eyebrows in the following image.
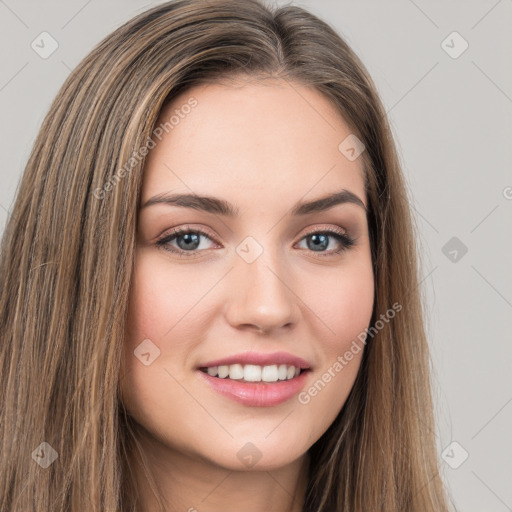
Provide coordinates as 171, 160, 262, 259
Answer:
121, 79, 374, 512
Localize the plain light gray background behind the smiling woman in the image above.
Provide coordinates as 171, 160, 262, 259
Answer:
0, 0, 512, 512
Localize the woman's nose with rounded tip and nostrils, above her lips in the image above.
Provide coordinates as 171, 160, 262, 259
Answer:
225, 246, 300, 333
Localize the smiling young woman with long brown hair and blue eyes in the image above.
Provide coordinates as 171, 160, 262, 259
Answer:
0, 0, 448, 512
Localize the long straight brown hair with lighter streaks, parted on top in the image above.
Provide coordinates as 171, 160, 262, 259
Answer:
0, 0, 448, 512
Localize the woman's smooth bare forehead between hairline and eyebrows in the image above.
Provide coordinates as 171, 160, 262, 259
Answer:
142, 79, 364, 207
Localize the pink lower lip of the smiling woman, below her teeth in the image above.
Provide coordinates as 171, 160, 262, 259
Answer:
197, 370, 309, 407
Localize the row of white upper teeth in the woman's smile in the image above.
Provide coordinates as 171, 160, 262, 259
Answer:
201, 363, 300, 382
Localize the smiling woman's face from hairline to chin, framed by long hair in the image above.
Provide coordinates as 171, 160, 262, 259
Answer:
121, 80, 374, 470
